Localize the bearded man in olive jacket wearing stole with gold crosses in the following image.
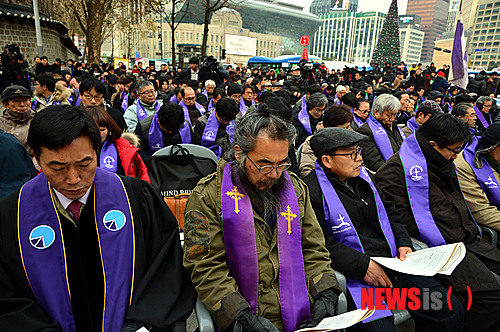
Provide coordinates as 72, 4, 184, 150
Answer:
184, 112, 340, 332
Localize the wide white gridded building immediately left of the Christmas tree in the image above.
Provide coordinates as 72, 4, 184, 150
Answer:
311, 11, 386, 63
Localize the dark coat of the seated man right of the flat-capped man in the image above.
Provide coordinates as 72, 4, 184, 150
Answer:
375, 132, 500, 293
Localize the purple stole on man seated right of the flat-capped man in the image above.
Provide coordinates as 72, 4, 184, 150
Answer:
399, 134, 446, 247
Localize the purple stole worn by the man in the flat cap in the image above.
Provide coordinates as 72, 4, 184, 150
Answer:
314, 162, 398, 323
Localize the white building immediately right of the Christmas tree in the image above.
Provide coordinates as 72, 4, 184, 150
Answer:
399, 15, 425, 65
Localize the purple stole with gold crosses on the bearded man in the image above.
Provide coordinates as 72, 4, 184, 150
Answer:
221, 163, 311, 332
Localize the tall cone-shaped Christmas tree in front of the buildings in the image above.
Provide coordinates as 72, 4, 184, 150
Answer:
370, 0, 401, 67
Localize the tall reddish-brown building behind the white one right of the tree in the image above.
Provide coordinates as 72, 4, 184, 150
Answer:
406, 0, 450, 64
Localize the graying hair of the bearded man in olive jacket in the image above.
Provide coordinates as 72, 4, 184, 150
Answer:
234, 112, 295, 158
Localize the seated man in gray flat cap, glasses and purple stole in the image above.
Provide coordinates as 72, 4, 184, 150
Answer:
304, 127, 464, 332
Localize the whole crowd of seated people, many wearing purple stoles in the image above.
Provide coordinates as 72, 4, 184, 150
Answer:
0, 57, 500, 332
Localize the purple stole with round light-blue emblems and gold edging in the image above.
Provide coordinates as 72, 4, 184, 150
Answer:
17, 168, 135, 332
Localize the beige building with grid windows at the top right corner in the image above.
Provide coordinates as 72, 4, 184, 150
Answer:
468, 0, 500, 70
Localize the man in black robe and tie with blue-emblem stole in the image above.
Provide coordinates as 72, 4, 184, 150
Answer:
0, 106, 195, 332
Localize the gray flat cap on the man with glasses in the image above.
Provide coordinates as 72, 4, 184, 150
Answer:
310, 127, 368, 158
